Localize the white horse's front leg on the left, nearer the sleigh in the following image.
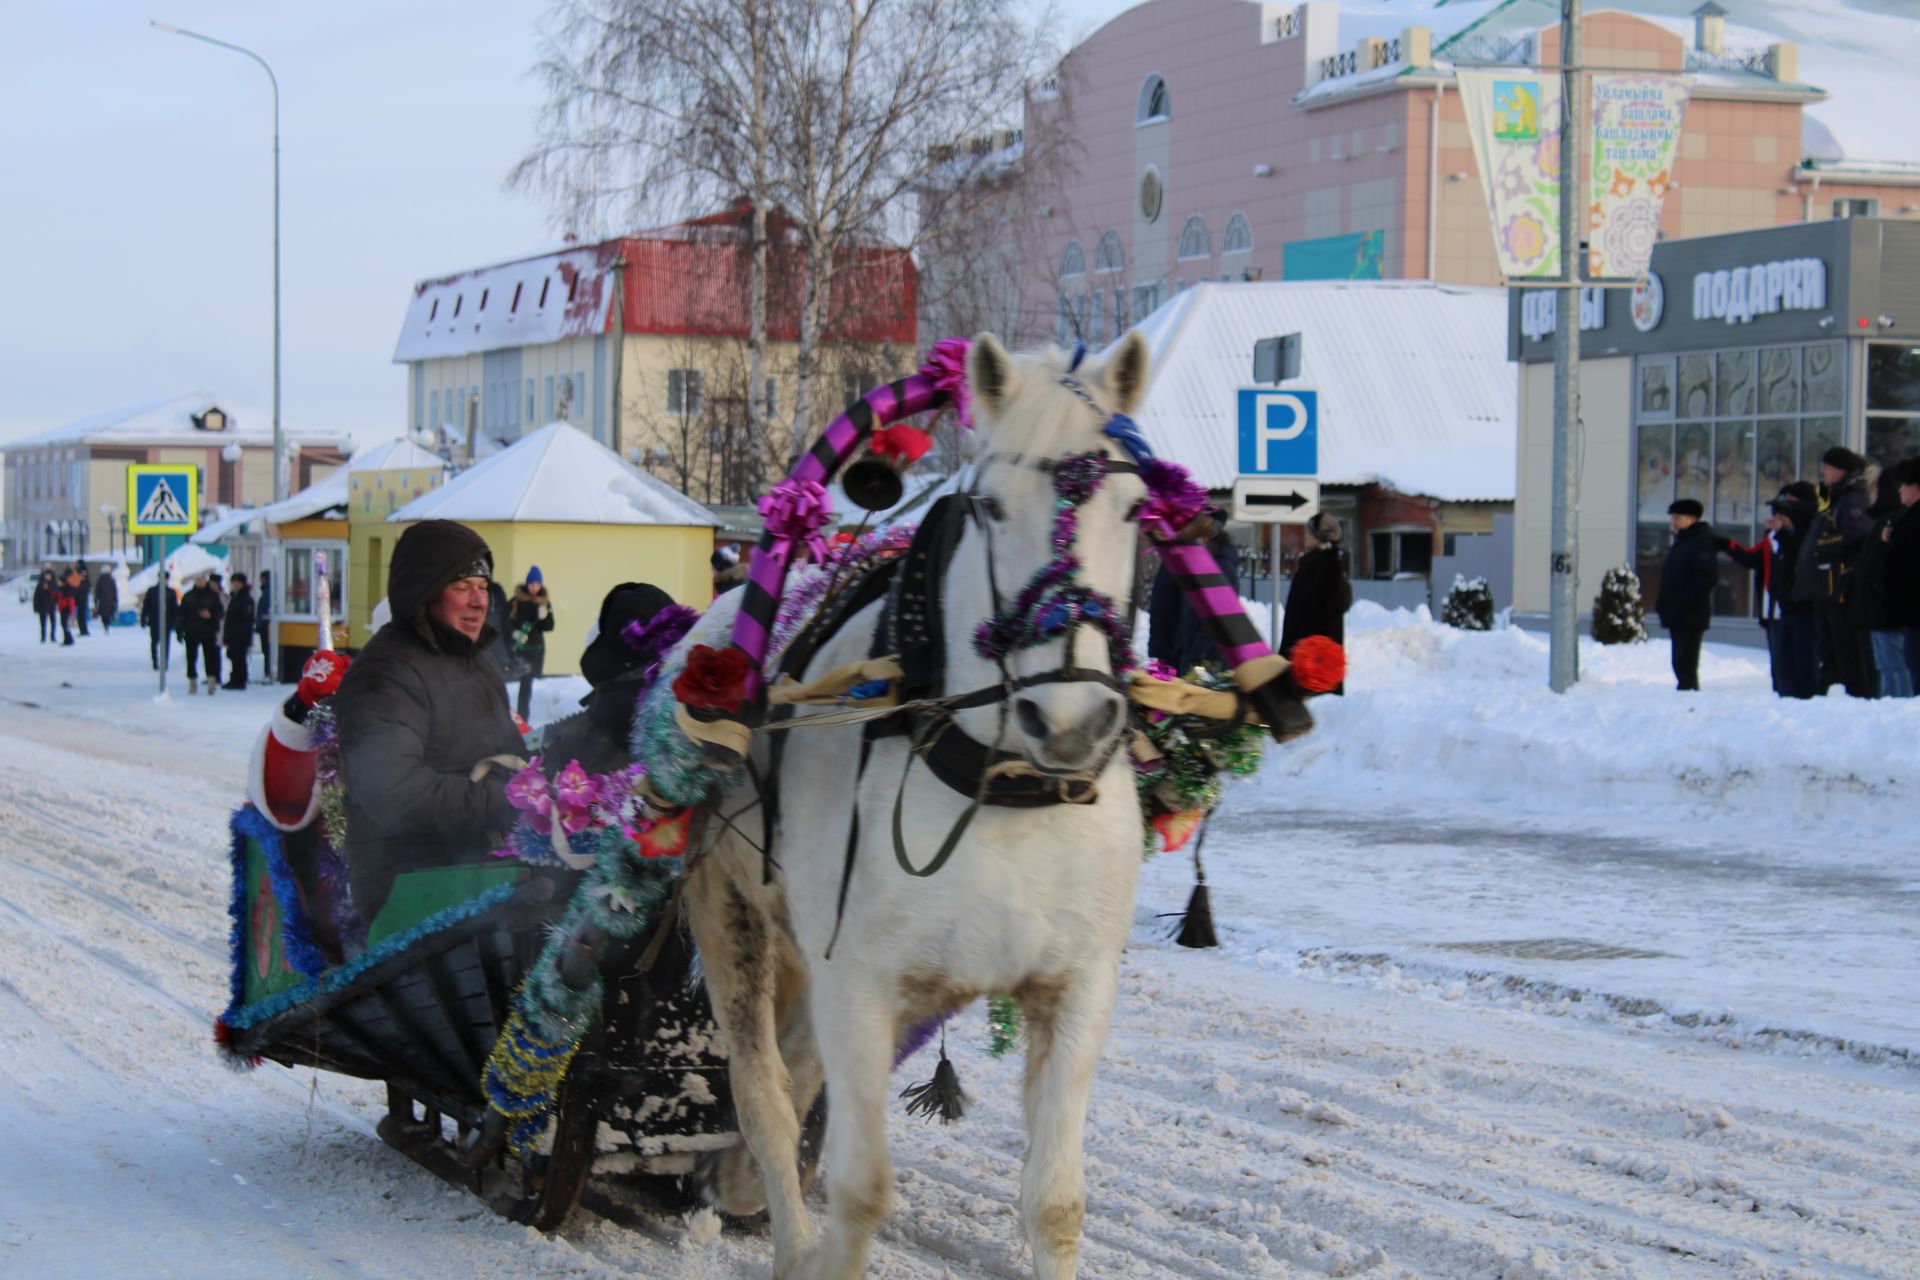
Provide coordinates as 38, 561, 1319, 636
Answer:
801, 965, 899, 1280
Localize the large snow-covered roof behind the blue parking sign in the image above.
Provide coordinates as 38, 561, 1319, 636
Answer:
1133, 280, 1519, 501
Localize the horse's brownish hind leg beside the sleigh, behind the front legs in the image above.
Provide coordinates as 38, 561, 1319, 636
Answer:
687, 856, 812, 1276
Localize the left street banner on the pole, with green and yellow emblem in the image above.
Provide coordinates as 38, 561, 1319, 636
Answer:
1455, 71, 1561, 280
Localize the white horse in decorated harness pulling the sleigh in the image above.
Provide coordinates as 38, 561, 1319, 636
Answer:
687, 334, 1148, 1280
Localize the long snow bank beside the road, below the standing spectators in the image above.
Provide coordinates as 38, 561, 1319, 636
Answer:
1260, 603, 1920, 841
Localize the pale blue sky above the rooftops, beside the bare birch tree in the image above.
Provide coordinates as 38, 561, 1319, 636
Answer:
0, 0, 1131, 450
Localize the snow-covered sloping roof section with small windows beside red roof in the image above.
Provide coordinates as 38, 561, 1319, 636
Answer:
394, 242, 618, 363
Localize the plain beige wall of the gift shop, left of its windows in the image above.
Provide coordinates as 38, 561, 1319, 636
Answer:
1513, 357, 1634, 612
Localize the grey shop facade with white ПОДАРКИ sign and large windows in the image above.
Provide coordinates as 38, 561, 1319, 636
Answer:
1507, 219, 1920, 628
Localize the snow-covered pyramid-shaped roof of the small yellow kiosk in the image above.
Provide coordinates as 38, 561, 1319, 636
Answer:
388, 422, 721, 528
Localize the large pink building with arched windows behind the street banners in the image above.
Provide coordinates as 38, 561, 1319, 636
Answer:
1018, 0, 1920, 344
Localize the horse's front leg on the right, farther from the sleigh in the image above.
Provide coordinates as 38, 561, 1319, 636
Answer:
1014, 960, 1119, 1280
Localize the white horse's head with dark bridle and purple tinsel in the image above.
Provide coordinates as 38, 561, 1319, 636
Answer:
945, 332, 1148, 773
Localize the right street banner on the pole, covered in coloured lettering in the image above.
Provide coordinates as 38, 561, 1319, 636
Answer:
1586, 75, 1688, 280
